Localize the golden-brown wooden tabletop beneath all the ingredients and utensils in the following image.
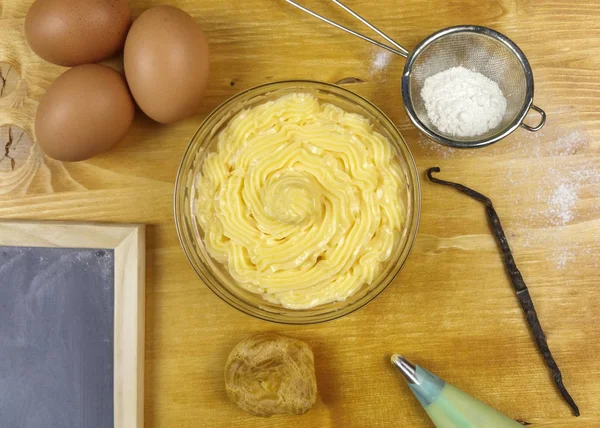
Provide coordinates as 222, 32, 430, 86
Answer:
0, 0, 600, 428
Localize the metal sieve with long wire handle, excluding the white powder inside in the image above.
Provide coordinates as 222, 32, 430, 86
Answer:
285, 0, 546, 148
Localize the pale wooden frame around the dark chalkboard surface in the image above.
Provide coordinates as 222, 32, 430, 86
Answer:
0, 221, 145, 428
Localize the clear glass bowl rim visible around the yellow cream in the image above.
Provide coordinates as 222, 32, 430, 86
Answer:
175, 80, 421, 324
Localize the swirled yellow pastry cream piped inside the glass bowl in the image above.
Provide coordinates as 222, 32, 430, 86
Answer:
196, 93, 406, 309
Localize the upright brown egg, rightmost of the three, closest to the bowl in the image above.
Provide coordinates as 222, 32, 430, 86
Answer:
124, 6, 208, 123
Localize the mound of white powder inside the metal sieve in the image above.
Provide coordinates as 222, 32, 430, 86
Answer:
421, 67, 506, 137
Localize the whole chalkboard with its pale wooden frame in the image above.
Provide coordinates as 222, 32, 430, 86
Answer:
0, 221, 145, 428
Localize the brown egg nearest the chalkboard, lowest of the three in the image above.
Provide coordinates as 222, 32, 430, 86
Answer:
35, 64, 135, 162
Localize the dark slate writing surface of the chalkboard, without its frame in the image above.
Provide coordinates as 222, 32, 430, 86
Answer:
0, 247, 114, 428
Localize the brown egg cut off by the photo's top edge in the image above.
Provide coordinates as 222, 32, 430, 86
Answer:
25, 0, 131, 67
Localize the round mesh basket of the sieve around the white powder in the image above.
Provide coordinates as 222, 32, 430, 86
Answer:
405, 31, 533, 145
